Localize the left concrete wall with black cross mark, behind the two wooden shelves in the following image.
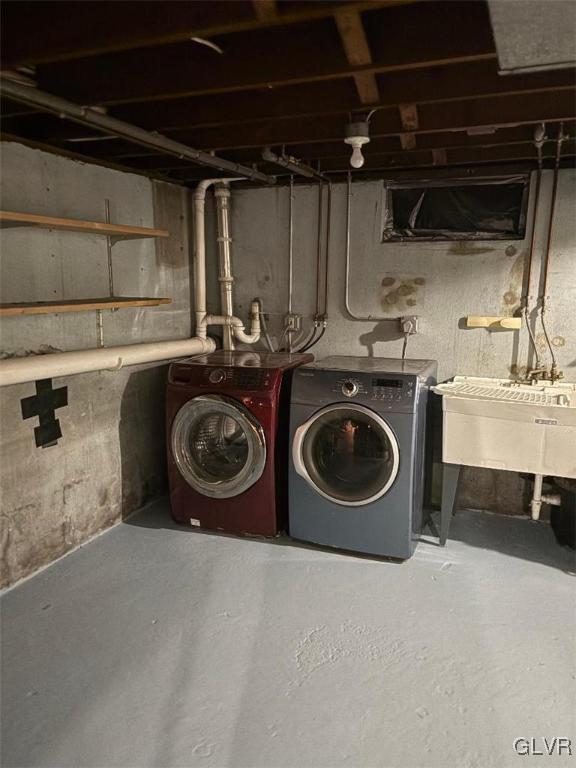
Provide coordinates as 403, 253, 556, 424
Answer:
0, 142, 191, 585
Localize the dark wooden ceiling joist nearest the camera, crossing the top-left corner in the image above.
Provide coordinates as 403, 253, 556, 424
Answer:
2, 0, 414, 68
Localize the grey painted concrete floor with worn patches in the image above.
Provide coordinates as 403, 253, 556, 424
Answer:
2, 502, 576, 768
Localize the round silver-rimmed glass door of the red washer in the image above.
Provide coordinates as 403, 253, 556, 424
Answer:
171, 395, 266, 498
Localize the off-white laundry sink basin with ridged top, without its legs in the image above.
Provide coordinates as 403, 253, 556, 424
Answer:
433, 376, 576, 477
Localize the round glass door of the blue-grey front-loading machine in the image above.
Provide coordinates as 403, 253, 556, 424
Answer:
293, 404, 399, 506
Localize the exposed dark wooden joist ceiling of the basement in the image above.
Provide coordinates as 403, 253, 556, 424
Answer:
2, 0, 576, 180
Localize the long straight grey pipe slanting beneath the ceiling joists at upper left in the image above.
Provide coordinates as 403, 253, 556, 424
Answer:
0, 77, 276, 184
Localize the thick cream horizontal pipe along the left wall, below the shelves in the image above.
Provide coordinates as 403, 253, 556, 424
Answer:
0, 338, 216, 387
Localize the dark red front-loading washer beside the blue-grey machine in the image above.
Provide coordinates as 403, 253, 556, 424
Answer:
166, 350, 313, 536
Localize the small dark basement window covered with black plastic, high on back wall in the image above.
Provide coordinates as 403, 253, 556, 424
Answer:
382, 175, 529, 242
